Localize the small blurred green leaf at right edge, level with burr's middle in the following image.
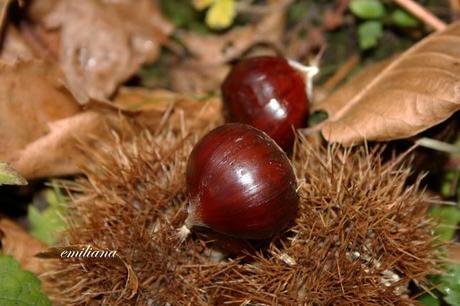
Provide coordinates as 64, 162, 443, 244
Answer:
430, 206, 460, 241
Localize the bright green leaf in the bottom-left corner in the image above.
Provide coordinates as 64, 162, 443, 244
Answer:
0, 256, 51, 306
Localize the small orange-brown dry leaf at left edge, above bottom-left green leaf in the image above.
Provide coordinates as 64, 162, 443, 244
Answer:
0, 217, 46, 274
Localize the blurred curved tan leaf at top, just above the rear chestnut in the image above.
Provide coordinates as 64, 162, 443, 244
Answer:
178, 0, 289, 65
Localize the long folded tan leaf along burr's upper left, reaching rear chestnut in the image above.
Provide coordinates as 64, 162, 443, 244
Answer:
10, 88, 221, 179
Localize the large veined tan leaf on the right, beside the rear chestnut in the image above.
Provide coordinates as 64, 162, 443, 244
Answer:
318, 22, 460, 145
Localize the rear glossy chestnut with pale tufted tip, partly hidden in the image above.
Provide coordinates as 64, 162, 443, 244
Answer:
221, 56, 308, 150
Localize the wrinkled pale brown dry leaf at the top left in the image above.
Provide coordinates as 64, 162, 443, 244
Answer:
31, 0, 173, 103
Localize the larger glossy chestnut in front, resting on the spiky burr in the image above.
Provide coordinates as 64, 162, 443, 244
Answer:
186, 123, 299, 239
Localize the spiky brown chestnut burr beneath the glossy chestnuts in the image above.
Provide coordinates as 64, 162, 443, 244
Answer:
44, 113, 438, 306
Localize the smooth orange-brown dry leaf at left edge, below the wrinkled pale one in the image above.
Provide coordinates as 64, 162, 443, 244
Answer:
0, 61, 80, 165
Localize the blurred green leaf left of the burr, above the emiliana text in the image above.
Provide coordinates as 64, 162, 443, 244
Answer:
28, 188, 66, 244
